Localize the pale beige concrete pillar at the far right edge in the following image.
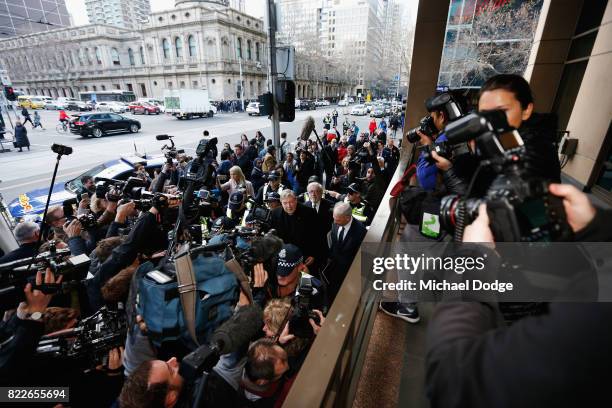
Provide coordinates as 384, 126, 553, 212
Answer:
563, 2, 612, 189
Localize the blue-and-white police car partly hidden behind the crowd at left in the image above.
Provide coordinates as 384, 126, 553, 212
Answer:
8, 154, 166, 221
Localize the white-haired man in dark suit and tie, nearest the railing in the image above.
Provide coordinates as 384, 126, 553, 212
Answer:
322, 202, 367, 304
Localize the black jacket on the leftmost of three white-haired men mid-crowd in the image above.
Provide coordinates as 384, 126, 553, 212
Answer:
270, 203, 324, 259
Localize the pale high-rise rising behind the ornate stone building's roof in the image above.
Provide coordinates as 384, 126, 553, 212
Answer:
85, 0, 151, 28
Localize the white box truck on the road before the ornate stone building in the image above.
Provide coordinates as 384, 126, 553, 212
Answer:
164, 89, 217, 119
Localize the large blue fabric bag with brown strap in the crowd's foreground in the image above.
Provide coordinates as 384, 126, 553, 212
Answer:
136, 247, 239, 349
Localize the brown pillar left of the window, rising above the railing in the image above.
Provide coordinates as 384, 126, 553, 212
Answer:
404, 0, 450, 131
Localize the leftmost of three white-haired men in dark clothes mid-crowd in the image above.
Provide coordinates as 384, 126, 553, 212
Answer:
270, 189, 325, 267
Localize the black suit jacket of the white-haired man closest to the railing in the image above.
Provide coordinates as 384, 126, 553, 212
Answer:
325, 222, 368, 302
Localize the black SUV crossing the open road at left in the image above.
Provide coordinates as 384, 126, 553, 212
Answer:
70, 113, 141, 137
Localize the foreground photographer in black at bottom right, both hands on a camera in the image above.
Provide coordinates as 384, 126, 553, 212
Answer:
426, 184, 612, 408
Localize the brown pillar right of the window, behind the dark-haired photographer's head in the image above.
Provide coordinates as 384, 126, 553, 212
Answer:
524, 0, 583, 112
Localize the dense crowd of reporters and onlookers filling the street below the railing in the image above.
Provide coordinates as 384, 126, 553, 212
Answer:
0, 107, 399, 408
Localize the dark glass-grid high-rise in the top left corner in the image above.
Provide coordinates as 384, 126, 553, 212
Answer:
0, 0, 71, 38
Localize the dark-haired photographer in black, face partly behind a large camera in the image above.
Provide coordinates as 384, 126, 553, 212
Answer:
478, 74, 561, 182
